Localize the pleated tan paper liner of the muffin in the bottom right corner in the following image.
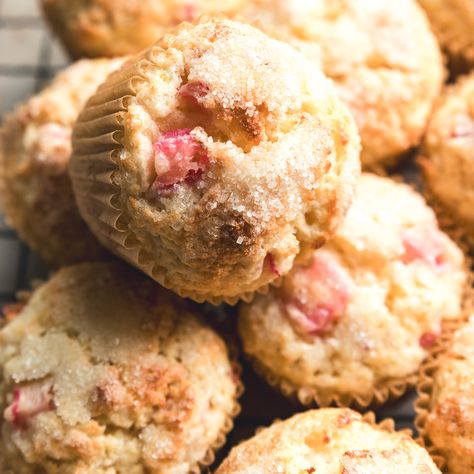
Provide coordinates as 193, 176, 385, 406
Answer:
415, 314, 468, 470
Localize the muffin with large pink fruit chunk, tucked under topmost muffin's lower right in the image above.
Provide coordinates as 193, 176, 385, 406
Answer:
239, 174, 467, 407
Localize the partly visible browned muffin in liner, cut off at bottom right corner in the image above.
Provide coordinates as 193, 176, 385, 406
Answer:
417, 316, 474, 474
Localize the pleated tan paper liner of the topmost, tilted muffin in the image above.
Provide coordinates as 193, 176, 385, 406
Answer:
70, 39, 286, 305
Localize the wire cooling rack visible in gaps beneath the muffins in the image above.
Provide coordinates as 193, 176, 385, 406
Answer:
0, 0, 414, 460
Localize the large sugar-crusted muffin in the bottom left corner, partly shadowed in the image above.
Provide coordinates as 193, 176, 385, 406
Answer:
0, 263, 239, 474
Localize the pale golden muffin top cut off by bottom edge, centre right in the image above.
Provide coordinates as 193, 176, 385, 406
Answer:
216, 408, 440, 474
